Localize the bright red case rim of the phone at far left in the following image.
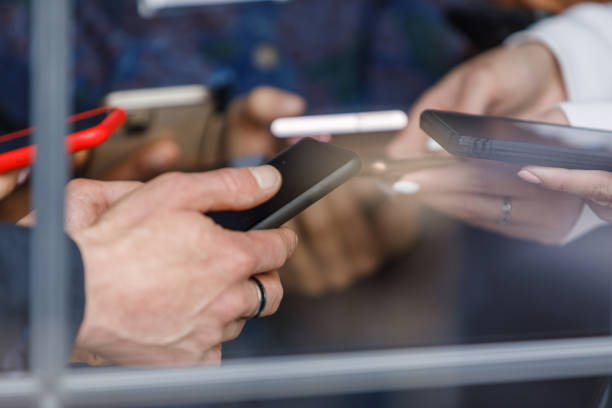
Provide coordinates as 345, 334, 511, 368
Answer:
0, 107, 127, 173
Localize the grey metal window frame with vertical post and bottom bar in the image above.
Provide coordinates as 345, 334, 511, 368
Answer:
0, 0, 612, 408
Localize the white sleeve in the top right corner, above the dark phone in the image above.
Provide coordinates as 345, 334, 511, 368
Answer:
506, 3, 612, 102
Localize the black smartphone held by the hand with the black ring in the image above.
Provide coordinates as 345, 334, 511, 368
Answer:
207, 138, 361, 231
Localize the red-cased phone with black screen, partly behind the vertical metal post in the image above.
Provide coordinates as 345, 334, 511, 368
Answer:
0, 107, 126, 173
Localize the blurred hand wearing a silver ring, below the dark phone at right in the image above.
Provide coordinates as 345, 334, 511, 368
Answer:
396, 160, 583, 244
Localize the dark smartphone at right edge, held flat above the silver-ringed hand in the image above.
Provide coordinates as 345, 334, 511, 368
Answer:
420, 110, 612, 171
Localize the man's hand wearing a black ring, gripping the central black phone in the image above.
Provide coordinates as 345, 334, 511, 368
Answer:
67, 166, 296, 365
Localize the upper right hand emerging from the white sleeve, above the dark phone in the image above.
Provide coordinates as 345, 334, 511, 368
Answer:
388, 43, 567, 158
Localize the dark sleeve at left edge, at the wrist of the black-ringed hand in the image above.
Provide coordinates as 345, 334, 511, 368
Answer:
0, 223, 85, 372
